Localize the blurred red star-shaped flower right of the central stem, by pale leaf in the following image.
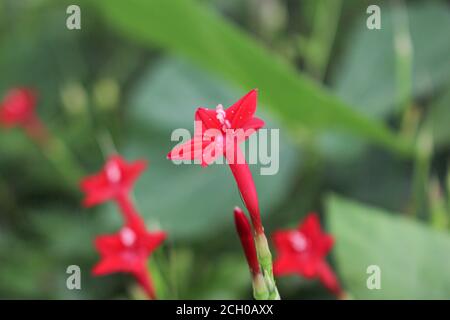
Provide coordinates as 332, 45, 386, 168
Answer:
272, 213, 342, 295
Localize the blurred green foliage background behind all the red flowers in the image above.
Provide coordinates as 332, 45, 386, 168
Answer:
0, 0, 450, 299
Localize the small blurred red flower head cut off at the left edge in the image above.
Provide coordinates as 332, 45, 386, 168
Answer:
0, 88, 36, 127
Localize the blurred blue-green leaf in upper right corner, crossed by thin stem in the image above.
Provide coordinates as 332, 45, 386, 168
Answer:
332, 1, 450, 118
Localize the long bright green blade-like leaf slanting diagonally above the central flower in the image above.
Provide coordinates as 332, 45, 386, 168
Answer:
95, 0, 409, 155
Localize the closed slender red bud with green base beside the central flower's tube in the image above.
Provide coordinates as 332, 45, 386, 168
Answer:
234, 207, 269, 300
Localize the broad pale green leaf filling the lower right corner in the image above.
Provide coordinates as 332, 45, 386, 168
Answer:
327, 197, 450, 299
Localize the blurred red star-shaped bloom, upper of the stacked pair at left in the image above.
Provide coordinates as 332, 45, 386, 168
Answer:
81, 155, 147, 208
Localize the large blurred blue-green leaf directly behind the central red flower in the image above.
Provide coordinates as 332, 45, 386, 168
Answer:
125, 59, 301, 239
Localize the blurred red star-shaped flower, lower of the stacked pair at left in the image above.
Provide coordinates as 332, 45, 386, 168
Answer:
92, 219, 166, 299
